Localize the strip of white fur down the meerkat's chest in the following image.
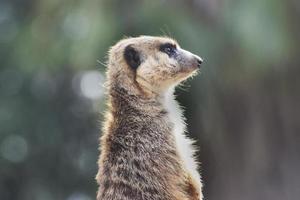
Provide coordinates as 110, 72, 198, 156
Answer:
164, 92, 200, 181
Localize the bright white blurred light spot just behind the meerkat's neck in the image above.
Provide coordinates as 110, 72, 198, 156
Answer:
73, 70, 104, 100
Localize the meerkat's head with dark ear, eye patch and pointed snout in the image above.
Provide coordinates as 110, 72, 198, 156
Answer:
108, 36, 202, 98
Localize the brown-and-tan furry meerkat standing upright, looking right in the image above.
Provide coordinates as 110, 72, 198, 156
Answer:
96, 36, 203, 200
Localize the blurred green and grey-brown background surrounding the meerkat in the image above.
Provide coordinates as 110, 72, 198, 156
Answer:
0, 0, 300, 200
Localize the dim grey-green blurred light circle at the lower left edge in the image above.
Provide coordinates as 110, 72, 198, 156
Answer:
0, 135, 28, 163
